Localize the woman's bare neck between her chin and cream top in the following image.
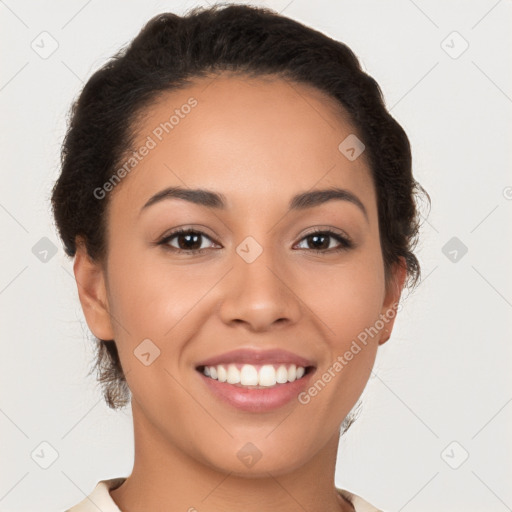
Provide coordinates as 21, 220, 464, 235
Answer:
110, 400, 354, 512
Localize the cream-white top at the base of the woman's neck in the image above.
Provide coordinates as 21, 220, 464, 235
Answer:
66, 477, 382, 512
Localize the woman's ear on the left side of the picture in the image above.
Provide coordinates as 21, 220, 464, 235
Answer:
73, 238, 114, 340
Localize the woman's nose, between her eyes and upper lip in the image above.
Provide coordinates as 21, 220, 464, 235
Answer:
219, 243, 302, 332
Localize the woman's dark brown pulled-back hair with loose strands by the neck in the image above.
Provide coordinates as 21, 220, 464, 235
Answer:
51, 4, 430, 412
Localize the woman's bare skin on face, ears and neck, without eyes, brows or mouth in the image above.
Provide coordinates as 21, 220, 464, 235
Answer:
74, 74, 406, 512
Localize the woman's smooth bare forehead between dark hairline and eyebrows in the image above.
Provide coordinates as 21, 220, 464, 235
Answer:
112, 73, 375, 216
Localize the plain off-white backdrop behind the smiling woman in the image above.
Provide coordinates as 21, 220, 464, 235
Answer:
0, 0, 512, 512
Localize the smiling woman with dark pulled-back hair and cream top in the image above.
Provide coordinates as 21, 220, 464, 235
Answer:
52, 5, 428, 512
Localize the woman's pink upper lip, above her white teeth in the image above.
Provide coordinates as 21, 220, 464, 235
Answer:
197, 348, 314, 368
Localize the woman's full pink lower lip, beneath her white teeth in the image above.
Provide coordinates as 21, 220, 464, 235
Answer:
198, 368, 314, 412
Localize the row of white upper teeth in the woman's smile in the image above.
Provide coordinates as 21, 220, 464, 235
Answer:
199, 364, 306, 387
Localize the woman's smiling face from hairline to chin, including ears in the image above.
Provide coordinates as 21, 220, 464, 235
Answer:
75, 75, 404, 476
